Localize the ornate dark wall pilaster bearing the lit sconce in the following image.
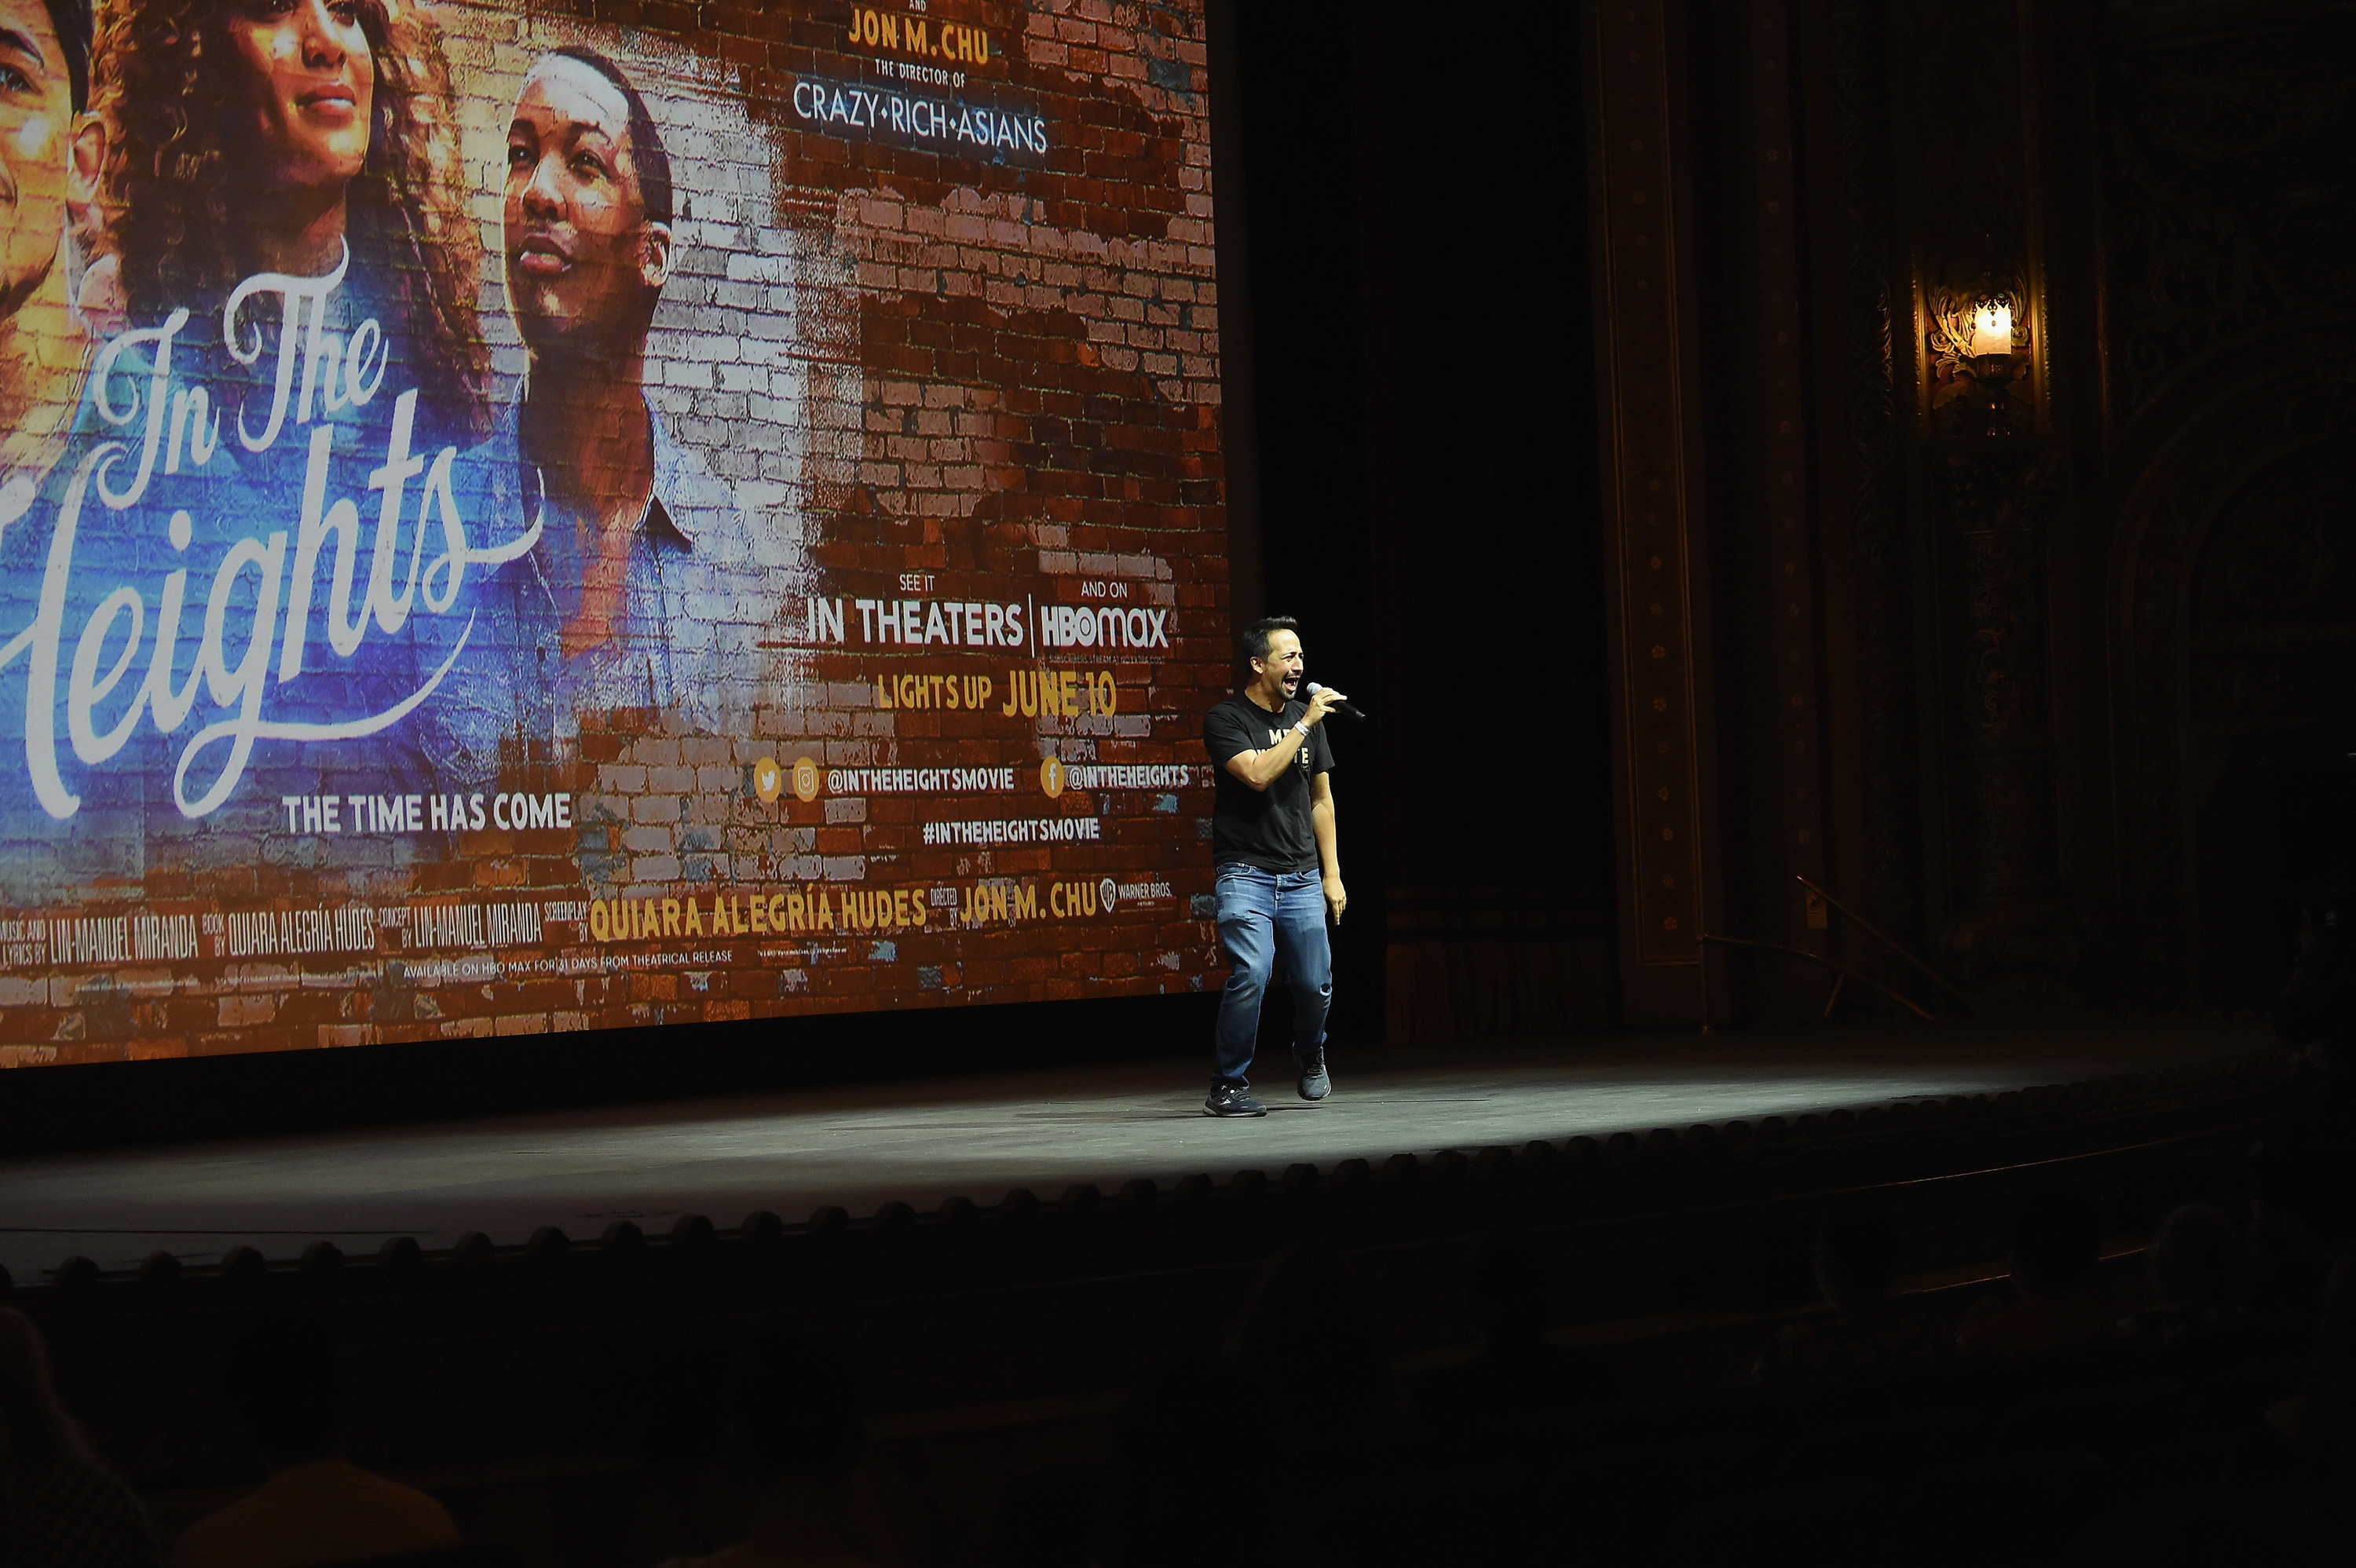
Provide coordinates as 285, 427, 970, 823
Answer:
1892, 0, 2078, 991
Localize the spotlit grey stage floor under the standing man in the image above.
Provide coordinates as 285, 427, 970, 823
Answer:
0, 1024, 2271, 1283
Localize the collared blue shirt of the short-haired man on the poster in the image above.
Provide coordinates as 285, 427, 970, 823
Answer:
434, 390, 777, 786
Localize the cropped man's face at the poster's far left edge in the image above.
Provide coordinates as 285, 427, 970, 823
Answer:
0, 0, 73, 318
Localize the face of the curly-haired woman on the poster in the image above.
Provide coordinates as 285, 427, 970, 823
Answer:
229, 0, 377, 188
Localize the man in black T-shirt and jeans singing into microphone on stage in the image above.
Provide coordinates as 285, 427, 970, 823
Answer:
1202, 615, 1350, 1116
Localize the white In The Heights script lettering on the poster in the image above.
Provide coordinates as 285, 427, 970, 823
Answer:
0, 247, 540, 817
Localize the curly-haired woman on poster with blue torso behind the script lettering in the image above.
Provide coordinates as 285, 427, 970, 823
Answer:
0, 0, 497, 885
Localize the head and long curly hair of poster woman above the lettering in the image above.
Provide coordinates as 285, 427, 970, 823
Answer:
92, 0, 490, 445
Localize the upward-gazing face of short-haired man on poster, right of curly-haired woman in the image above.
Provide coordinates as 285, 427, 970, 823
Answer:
504, 57, 667, 349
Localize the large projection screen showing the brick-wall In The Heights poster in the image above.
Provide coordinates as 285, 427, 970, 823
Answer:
0, 0, 1227, 1066
